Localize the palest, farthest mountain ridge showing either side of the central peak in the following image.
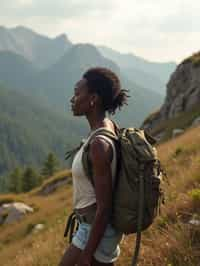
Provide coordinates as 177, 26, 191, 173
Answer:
0, 26, 174, 94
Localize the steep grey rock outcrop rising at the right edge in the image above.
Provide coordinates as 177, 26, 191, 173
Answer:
141, 52, 200, 131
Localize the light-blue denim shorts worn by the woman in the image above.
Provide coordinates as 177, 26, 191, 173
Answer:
72, 223, 123, 263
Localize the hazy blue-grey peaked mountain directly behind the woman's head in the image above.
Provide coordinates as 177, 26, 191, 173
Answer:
0, 44, 163, 126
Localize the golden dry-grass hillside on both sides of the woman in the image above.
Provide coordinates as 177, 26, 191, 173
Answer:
0, 127, 200, 266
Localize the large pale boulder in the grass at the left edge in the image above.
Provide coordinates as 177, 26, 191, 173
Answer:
0, 202, 34, 224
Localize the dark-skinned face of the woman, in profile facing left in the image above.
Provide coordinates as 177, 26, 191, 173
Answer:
70, 78, 92, 116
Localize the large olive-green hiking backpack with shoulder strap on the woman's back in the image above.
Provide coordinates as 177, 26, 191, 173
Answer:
82, 125, 164, 265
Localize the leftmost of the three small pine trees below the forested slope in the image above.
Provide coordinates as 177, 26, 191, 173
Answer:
8, 167, 23, 193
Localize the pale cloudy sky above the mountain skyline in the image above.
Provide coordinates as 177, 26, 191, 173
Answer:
0, 0, 200, 63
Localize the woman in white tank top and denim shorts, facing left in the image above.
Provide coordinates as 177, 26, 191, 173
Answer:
59, 68, 128, 266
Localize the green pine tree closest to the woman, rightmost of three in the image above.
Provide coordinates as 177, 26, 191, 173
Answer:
42, 152, 59, 177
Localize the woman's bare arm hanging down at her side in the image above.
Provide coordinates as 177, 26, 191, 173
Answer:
81, 137, 113, 257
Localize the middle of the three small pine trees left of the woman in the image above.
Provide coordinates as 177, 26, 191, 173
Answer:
22, 167, 39, 192
